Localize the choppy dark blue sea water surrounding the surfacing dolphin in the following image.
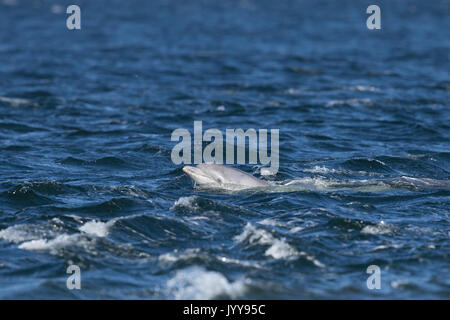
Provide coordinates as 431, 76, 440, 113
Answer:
0, 0, 450, 299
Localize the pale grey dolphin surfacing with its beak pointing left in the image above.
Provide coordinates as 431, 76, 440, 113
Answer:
183, 163, 269, 191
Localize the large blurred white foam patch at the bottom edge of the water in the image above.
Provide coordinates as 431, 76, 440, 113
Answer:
167, 266, 246, 300
